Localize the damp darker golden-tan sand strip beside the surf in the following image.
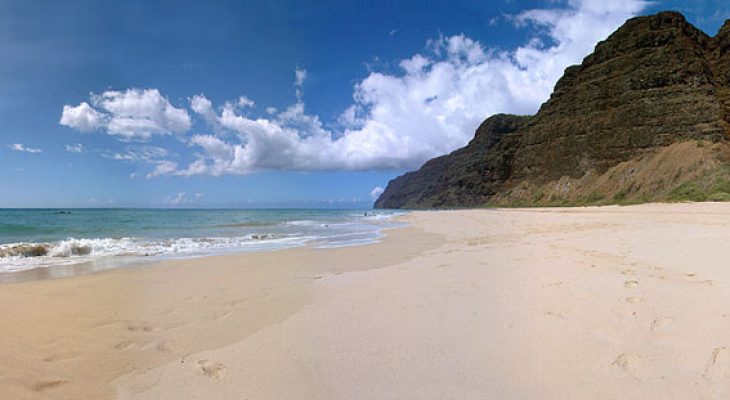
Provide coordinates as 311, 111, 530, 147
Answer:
0, 219, 438, 399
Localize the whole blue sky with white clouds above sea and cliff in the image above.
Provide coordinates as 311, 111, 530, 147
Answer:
0, 0, 730, 207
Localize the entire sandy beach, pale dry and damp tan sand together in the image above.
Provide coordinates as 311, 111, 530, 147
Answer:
0, 203, 730, 399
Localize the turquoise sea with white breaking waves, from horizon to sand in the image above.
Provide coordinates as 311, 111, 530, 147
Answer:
0, 209, 400, 272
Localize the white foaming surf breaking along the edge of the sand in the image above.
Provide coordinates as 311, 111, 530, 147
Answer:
0, 210, 401, 272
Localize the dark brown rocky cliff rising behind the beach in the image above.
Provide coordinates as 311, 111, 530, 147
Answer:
375, 12, 730, 208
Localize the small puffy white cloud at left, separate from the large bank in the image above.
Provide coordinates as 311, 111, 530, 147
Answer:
60, 89, 190, 140
